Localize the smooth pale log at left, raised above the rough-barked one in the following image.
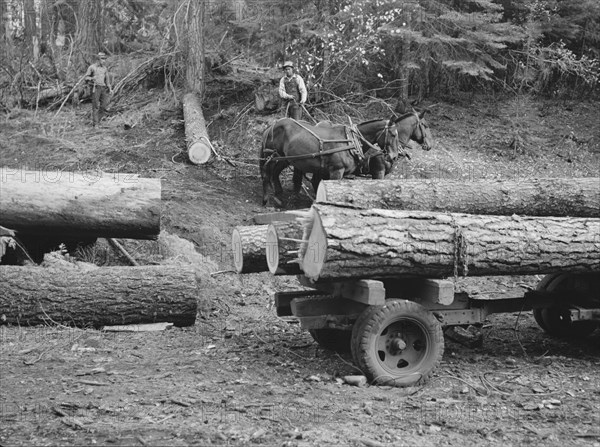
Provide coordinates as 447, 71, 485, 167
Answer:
0, 168, 161, 239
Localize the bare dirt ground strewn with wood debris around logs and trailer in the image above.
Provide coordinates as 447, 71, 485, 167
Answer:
0, 92, 600, 446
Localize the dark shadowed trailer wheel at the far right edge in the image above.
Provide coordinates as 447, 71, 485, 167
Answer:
533, 273, 598, 338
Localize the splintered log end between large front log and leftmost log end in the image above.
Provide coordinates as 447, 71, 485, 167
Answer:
266, 221, 304, 275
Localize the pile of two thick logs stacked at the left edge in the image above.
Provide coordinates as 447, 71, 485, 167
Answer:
0, 168, 198, 327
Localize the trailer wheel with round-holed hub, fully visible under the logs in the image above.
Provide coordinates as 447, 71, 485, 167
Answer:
351, 299, 444, 387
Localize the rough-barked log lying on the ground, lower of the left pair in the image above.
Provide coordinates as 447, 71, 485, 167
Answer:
0, 265, 198, 327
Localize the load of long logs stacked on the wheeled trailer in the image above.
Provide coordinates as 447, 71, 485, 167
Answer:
238, 178, 600, 282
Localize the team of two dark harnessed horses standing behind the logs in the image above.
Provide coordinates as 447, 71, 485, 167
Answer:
260, 112, 432, 205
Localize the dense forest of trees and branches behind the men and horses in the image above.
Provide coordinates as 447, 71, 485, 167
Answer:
0, 0, 600, 110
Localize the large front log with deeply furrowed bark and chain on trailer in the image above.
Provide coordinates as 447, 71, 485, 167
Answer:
299, 204, 600, 281
